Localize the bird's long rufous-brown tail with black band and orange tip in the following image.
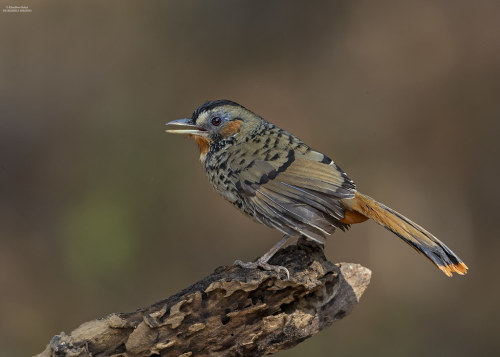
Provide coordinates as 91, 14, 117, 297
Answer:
342, 192, 468, 276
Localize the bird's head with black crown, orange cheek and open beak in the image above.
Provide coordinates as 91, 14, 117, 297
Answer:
166, 100, 262, 158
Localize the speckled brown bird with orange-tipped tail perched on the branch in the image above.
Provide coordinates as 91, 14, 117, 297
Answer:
166, 99, 468, 278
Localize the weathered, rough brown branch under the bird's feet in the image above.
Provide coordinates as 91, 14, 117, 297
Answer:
38, 239, 371, 357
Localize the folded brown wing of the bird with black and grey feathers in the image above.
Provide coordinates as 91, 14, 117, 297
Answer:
236, 149, 355, 243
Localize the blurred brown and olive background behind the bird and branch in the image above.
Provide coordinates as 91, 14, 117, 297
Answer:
0, 0, 500, 356
